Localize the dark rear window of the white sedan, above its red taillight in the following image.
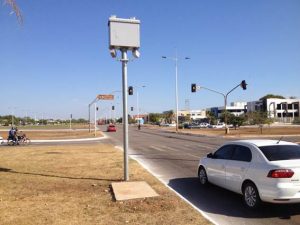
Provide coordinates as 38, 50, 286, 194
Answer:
259, 145, 300, 161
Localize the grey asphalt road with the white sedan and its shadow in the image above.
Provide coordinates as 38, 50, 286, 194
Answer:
101, 127, 300, 225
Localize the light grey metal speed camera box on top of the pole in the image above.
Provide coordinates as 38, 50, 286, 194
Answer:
108, 17, 140, 49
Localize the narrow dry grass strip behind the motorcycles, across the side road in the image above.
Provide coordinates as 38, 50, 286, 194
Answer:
0, 130, 102, 140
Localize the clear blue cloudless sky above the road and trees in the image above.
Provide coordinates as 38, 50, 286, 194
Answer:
0, 0, 300, 119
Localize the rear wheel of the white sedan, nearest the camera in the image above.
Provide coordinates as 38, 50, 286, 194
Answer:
243, 182, 261, 209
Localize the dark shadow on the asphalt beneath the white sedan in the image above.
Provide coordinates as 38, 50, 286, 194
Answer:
168, 177, 300, 220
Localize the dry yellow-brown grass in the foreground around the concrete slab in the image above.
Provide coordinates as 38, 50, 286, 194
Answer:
0, 144, 209, 225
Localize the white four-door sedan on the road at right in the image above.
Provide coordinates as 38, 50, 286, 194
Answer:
198, 140, 300, 209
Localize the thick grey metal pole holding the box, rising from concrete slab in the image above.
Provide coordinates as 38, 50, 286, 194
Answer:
121, 49, 129, 181
